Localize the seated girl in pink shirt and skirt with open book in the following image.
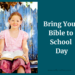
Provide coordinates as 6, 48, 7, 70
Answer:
0, 12, 31, 73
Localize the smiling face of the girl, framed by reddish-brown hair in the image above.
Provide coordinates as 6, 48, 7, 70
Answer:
9, 15, 22, 28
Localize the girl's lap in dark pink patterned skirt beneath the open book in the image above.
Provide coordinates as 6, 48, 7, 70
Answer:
0, 58, 25, 73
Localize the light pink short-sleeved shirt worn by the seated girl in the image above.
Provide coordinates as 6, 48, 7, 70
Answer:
0, 29, 28, 51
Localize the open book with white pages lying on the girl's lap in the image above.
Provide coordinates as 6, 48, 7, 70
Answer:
0, 50, 26, 62
